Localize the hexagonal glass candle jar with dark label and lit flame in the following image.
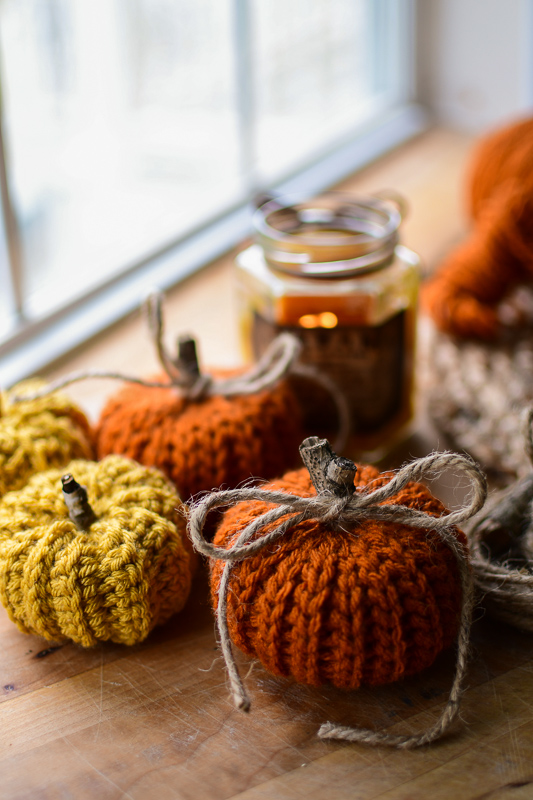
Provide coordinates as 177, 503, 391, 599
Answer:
237, 192, 419, 454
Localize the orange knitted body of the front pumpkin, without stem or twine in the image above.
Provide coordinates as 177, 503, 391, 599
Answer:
211, 466, 466, 689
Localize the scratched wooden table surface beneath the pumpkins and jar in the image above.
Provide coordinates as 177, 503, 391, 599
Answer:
4, 131, 533, 800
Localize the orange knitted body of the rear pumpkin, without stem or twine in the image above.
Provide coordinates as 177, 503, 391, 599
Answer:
96, 376, 303, 498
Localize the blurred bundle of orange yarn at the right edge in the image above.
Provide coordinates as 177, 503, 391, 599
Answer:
422, 119, 533, 340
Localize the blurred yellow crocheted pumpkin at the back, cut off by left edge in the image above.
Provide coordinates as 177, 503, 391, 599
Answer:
0, 381, 94, 497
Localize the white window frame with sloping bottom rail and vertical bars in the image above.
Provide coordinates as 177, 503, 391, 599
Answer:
0, 0, 428, 387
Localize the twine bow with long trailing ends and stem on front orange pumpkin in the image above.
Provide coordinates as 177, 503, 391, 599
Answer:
189, 437, 487, 748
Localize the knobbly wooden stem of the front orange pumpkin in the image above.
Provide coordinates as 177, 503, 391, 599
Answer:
300, 436, 357, 497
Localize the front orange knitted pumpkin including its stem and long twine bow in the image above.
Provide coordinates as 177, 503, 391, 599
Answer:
189, 436, 487, 748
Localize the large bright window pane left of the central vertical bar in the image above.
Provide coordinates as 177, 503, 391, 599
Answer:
0, 0, 242, 317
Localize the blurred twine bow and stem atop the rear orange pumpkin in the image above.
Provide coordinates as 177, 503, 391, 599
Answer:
10, 291, 351, 449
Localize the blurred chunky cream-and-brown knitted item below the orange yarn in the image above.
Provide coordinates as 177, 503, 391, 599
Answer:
422, 301, 533, 484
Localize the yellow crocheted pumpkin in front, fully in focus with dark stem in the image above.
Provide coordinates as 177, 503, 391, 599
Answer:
0, 456, 193, 647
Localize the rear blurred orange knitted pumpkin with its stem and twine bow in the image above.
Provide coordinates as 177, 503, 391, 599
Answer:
93, 295, 347, 498
